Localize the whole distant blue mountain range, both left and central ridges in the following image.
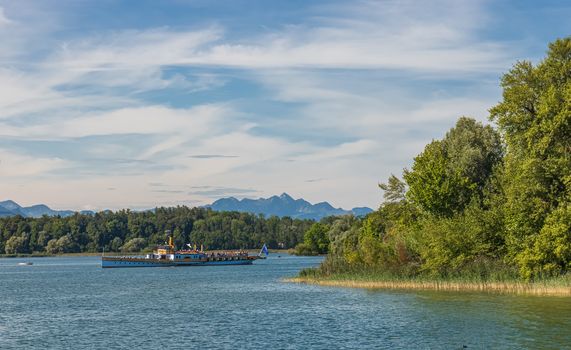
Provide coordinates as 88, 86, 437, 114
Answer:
0, 193, 373, 220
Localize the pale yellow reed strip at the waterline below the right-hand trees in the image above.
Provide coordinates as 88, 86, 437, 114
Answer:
284, 277, 571, 297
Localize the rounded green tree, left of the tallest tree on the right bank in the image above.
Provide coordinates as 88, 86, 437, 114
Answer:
404, 117, 503, 217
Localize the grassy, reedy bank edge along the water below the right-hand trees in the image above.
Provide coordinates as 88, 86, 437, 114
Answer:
286, 274, 571, 296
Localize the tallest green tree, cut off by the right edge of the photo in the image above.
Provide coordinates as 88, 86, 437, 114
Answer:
490, 37, 571, 278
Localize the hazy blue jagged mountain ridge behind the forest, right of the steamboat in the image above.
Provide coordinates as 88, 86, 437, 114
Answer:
206, 193, 373, 220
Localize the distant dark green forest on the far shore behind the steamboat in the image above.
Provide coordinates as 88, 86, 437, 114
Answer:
0, 206, 314, 254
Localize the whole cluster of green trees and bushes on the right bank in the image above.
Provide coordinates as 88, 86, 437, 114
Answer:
308, 37, 571, 280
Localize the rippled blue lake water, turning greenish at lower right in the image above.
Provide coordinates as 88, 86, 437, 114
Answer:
0, 255, 571, 349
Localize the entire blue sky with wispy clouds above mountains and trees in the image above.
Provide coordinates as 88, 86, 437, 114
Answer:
0, 0, 571, 210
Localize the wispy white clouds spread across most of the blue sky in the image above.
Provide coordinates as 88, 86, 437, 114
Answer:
0, 0, 510, 209
